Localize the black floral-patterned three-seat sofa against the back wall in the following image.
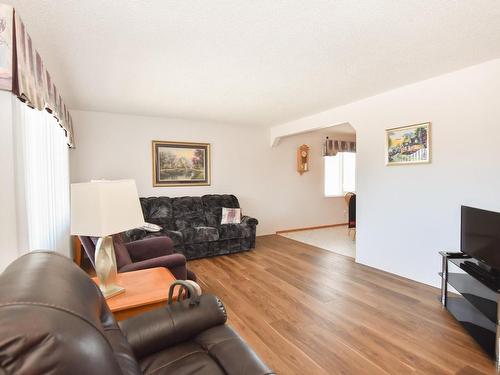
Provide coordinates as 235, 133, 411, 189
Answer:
125, 194, 259, 259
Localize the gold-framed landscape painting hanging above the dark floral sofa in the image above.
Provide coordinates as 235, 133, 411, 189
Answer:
153, 141, 210, 186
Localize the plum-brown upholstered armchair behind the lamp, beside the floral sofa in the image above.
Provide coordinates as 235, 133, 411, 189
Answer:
79, 235, 196, 281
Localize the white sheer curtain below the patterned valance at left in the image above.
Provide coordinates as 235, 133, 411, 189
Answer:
13, 99, 70, 256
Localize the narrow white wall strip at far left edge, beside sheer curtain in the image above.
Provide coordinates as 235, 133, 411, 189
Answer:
0, 91, 18, 272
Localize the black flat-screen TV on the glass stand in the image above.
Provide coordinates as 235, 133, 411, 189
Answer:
460, 206, 500, 270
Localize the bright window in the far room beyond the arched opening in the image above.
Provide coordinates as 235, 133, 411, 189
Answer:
323, 152, 356, 197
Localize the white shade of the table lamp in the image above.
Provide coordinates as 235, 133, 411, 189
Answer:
71, 180, 144, 237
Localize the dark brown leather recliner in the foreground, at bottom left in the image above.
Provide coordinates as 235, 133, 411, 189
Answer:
0, 252, 272, 375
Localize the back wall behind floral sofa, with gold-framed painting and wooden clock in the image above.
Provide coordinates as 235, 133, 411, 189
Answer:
70, 111, 346, 234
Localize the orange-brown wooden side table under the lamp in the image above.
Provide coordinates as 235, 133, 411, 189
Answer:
92, 267, 177, 320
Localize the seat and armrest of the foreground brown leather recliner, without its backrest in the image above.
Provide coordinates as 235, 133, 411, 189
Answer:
119, 295, 272, 375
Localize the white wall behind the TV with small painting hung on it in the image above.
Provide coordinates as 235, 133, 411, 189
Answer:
271, 60, 500, 286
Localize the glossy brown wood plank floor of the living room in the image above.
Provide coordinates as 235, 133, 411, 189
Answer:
189, 235, 496, 375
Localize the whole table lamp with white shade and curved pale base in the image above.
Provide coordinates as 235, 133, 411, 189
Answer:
71, 180, 144, 298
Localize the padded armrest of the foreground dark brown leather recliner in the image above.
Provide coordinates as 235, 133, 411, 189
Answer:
119, 294, 227, 360
